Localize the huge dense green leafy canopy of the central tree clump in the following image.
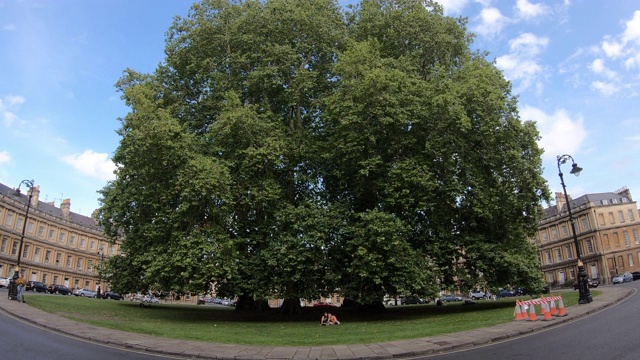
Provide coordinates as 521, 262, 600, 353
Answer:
100, 0, 549, 310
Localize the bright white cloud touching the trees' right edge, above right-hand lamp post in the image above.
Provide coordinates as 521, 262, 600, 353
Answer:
520, 105, 587, 159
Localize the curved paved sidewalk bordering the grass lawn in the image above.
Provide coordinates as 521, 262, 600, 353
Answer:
0, 286, 635, 360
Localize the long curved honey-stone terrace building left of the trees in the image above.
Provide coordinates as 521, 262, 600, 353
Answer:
0, 184, 119, 290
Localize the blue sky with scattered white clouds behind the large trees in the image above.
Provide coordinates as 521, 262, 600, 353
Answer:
0, 0, 640, 215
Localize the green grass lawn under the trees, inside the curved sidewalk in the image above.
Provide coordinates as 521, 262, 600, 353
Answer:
26, 290, 601, 346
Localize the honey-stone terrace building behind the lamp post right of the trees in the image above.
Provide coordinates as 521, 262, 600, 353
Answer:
534, 187, 640, 287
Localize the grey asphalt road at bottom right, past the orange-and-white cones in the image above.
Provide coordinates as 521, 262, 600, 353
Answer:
416, 281, 640, 360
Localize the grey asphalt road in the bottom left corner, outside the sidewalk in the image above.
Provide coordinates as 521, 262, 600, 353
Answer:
0, 289, 176, 360
